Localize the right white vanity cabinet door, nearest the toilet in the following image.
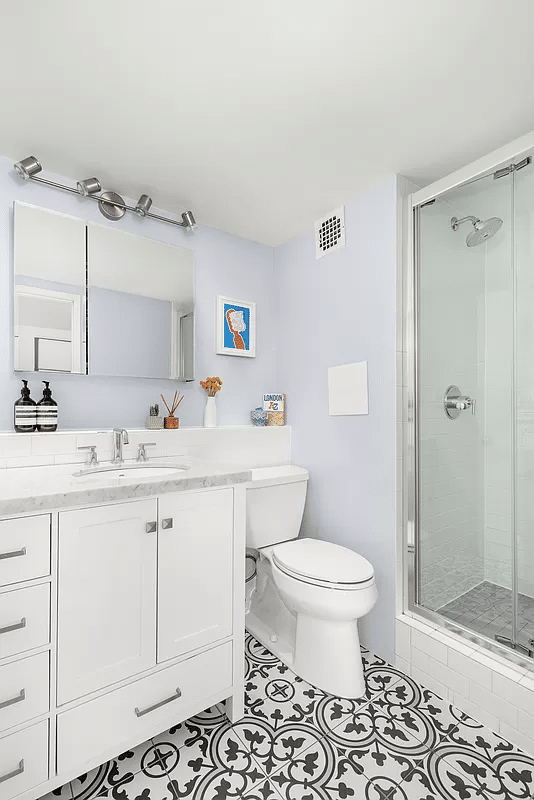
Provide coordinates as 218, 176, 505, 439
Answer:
158, 489, 234, 661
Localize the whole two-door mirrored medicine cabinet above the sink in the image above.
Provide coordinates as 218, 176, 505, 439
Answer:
13, 202, 195, 381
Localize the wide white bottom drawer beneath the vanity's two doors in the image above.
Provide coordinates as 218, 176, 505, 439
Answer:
57, 642, 232, 774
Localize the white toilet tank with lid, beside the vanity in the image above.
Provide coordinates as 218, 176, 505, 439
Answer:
247, 466, 308, 550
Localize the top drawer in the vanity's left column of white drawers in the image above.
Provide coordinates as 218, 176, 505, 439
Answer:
0, 514, 50, 586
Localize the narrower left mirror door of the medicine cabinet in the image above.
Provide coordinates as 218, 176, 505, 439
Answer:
13, 203, 87, 374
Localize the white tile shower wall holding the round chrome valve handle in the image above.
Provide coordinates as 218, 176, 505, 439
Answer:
419, 201, 484, 610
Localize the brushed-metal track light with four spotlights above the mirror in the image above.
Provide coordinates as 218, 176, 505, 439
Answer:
13, 156, 196, 231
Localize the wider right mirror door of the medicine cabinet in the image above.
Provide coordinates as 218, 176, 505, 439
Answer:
88, 224, 194, 380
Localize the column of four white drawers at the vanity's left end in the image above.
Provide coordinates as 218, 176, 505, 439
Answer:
0, 514, 51, 800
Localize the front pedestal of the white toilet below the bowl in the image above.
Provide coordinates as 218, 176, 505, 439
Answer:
292, 613, 365, 699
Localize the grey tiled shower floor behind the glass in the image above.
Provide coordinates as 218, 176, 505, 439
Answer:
437, 581, 534, 646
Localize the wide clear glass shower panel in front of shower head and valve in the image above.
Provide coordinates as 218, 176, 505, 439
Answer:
416, 170, 516, 639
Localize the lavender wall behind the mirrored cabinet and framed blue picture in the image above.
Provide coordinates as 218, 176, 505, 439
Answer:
0, 158, 278, 430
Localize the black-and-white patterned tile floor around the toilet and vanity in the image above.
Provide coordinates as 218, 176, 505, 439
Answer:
42, 635, 534, 800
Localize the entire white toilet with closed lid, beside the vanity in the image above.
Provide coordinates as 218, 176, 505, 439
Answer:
246, 466, 377, 698
